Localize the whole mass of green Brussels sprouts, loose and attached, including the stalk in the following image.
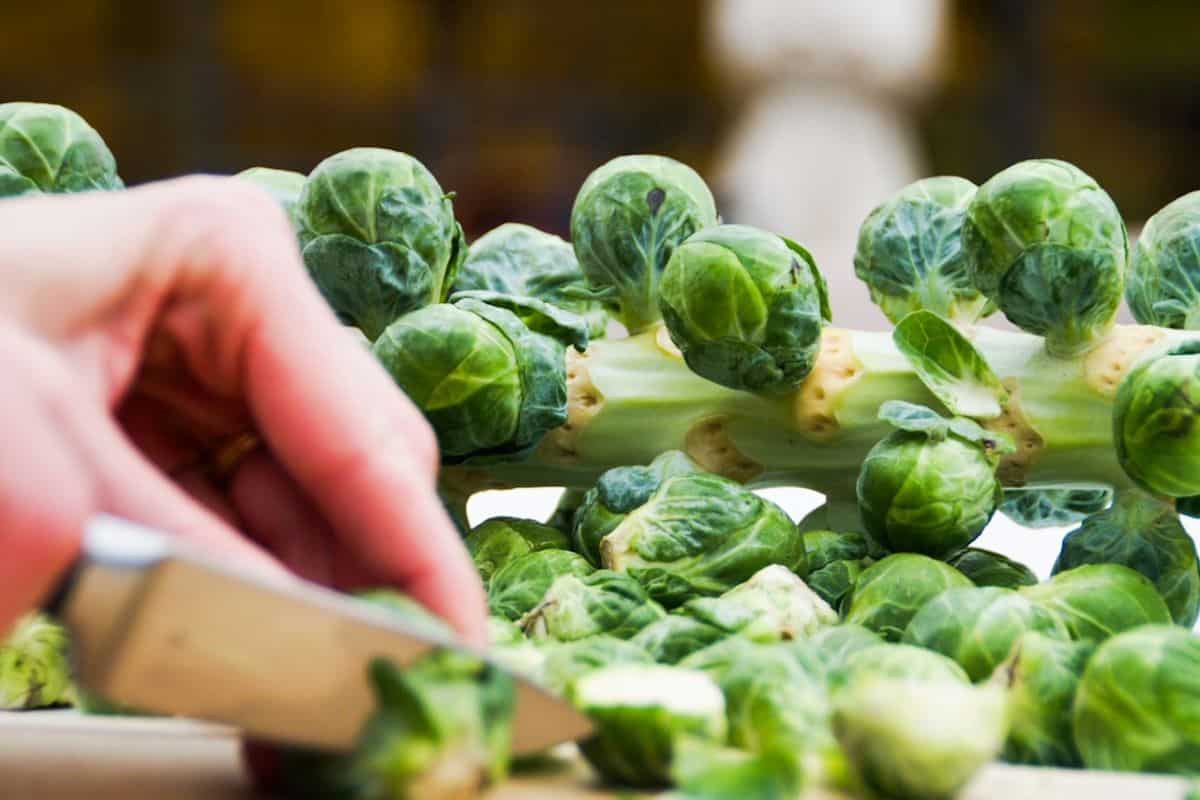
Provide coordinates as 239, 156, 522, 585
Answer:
7, 103, 1200, 800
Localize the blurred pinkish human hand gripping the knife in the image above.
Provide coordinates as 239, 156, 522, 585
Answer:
0, 178, 485, 643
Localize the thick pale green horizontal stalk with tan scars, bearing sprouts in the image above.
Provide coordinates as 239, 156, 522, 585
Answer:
445, 326, 1187, 498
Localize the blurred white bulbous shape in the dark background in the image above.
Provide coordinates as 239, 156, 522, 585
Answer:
708, 0, 946, 329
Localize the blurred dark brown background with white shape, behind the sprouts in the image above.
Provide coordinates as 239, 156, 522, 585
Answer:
9, 0, 1200, 575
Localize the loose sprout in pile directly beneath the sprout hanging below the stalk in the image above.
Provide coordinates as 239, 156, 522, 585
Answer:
846, 553, 971, 642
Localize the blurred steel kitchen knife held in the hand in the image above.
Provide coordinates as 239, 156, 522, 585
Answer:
47, 515, 590, 754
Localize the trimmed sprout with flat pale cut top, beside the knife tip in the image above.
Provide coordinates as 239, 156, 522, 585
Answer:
571, 664, 725, 787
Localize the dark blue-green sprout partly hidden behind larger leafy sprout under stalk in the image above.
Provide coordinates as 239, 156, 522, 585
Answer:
571, 450, 702, 566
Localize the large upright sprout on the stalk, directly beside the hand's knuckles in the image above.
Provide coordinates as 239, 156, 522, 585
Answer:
296, 148, 467, 341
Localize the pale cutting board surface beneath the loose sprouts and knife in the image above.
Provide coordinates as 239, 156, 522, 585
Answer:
0, 711, 1190, 800
